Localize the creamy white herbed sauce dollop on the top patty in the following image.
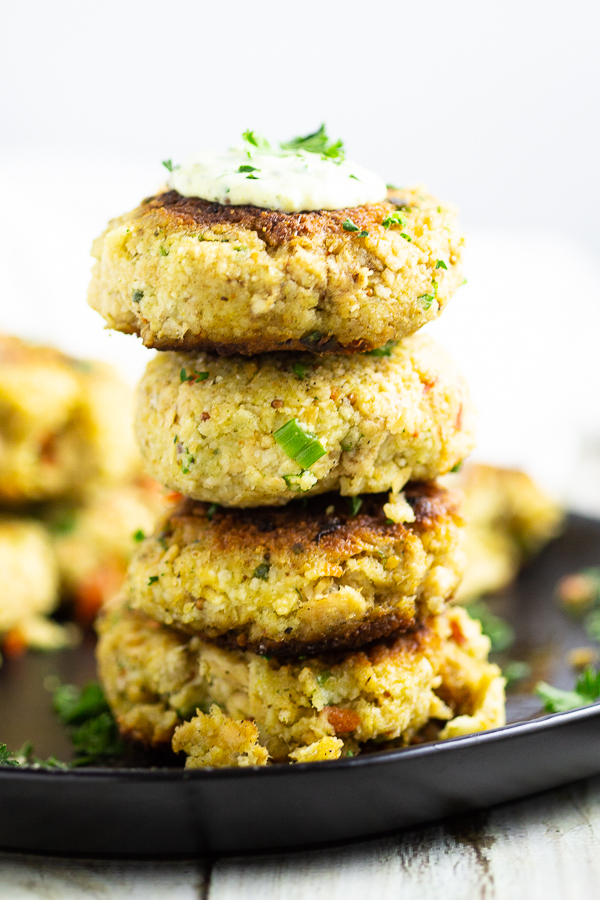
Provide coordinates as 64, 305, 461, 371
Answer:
168, 145, 387, 213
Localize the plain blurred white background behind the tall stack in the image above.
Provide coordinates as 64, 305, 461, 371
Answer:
0, 0, 600, 513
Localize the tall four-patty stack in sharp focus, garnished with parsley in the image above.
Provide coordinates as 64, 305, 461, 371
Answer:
90, 132, 504, 767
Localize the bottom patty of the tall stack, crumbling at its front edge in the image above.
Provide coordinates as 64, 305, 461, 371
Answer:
97, 600, 504, 765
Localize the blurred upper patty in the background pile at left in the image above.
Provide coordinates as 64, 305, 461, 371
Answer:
0, 335, 137, 504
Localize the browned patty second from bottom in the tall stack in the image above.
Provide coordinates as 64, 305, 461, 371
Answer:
127, 484, 464, 656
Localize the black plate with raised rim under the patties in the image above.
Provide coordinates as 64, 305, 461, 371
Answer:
0, 516, 600, 857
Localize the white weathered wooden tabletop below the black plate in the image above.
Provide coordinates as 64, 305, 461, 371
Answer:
0, 776, 600, 900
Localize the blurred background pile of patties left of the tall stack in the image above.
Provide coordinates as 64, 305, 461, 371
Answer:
0, 335, 175, 656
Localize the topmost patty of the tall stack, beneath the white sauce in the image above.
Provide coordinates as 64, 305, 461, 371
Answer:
88, 188, 463, 355
